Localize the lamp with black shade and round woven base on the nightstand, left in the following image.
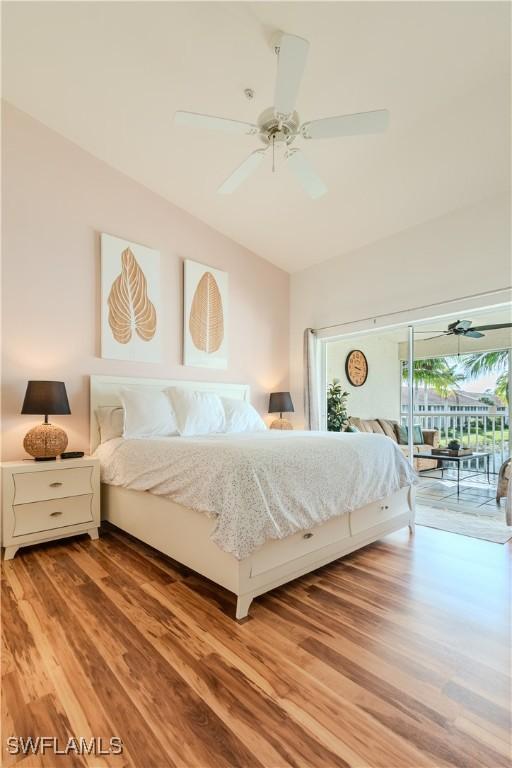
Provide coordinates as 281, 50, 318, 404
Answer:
21, 381, 71, 461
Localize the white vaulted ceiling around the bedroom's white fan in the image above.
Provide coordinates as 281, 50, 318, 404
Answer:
3, 2, 510, 272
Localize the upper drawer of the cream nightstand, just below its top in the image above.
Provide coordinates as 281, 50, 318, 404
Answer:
13, 467, 93, 504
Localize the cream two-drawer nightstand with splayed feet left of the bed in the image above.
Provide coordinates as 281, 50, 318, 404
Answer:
1, 456, 100, 560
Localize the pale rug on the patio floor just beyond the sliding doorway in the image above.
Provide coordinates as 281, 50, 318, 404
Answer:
416, 504, 512, 544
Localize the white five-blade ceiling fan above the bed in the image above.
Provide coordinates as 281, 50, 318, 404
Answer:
175, 34, 389, 199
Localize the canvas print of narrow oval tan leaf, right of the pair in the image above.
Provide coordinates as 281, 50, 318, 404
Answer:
183, 259, 228, 368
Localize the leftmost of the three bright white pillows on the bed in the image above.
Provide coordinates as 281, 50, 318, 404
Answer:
120, 389, 178, 438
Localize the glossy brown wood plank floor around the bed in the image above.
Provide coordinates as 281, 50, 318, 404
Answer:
2, 527, 510, 768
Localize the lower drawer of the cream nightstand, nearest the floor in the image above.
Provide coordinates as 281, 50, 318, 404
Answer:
13, 496, 93, 536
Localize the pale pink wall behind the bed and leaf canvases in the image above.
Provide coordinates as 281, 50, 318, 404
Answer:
2, 105, 289, 459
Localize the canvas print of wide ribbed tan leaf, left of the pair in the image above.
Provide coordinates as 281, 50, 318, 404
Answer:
101, 234, 161, 363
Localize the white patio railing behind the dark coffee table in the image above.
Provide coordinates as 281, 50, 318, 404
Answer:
401, 411, 510, 472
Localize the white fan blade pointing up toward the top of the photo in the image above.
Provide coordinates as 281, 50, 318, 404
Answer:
274, 35, 309, 117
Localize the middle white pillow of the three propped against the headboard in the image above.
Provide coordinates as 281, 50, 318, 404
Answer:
165, 387, 226, 437
